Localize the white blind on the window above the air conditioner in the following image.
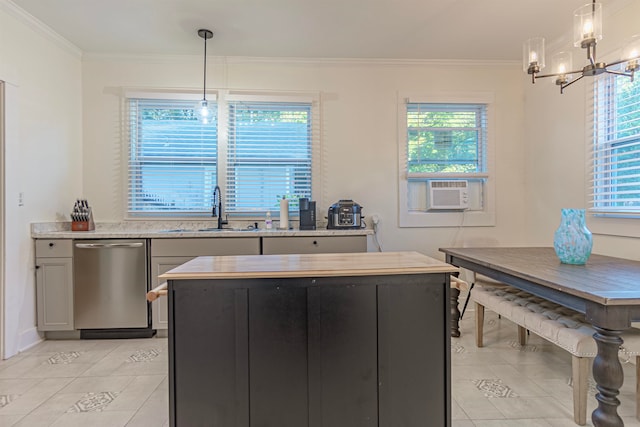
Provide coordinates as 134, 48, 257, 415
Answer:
406, 103, 487, 178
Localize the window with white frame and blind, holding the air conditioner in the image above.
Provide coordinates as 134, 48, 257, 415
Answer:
398, 95, 493, 227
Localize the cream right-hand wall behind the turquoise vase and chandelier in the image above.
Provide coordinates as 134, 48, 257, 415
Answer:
525, 1, 640, 259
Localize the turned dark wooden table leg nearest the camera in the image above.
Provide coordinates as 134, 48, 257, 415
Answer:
591, 325, 624, 427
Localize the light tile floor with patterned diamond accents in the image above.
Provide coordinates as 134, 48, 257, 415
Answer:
0, 312, 640, 427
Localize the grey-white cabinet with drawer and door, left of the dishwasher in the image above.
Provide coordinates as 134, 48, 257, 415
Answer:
36, 239, 73, 331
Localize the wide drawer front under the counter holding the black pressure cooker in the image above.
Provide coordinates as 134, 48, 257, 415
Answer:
262, 236, 367, 255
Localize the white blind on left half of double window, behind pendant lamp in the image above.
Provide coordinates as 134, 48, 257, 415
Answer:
127, 98, 218, 216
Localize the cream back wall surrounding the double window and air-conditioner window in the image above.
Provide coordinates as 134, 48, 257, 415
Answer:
83, 56, 526, 258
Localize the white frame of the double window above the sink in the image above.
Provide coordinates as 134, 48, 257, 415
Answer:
121, 89, 323, 221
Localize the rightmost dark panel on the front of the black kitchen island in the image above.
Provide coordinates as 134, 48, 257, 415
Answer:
378, 274, 451, 427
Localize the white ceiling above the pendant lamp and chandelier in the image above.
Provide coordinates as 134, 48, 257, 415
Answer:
12, 0, 628, 60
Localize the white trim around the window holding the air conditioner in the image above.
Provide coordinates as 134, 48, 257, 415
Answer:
397, 92, 496, 228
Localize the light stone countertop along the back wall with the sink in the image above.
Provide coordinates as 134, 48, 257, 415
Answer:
31, 221, 373, 239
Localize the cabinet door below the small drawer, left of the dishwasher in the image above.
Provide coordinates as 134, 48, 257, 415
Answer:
36, 258, 73, 331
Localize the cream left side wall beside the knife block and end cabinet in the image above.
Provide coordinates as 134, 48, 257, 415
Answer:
0, 0, 82, 358
